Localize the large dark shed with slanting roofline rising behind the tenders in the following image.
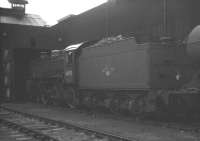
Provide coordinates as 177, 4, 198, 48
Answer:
52, 0, 200, 45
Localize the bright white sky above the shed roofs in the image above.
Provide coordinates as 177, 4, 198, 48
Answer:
0, 0, 107, 25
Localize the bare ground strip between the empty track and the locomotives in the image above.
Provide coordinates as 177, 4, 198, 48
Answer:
3, 103, 200, 141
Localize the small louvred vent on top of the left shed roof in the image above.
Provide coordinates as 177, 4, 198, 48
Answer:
8, 0, 28, 16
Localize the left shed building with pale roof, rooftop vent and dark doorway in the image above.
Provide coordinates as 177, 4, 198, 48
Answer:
0, 1, 47, 100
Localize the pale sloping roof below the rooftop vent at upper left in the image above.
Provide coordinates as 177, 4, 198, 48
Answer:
0, 14, 47, 26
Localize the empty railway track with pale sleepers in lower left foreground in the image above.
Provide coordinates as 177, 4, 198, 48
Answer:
0, 107, 137, 141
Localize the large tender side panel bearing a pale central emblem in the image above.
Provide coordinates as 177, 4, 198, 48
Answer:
79, 39, 149, 90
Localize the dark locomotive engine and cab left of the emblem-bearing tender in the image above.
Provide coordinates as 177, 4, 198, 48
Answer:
27, 50, 75, 104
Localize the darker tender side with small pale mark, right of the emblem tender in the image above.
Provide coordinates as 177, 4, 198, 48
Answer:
149, 44, 192, 89
